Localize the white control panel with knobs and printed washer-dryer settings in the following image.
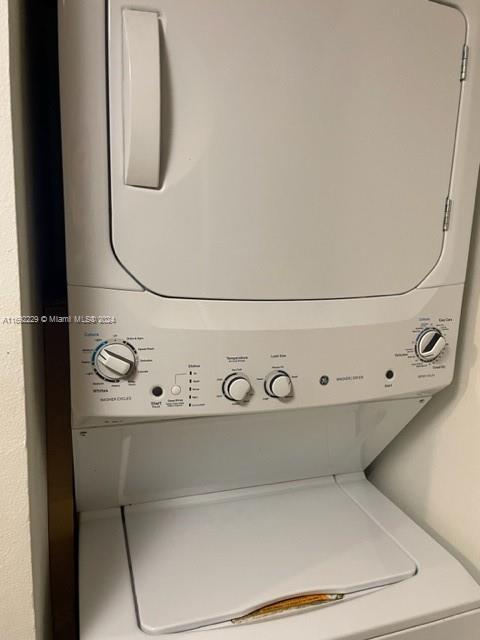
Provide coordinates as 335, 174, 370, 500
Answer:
70, 285, 462, 426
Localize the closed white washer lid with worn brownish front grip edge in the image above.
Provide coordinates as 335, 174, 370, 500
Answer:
125, 478, 416, 633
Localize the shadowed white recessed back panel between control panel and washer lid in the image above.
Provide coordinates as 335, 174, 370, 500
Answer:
73, 398, 428, 511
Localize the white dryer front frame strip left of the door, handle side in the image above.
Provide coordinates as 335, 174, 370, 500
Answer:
58, 0, 141, 290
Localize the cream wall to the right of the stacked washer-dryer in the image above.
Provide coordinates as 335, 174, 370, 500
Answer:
370, 182, 480, 588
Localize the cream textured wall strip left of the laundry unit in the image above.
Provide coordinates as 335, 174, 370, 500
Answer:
0, 0, 49, 640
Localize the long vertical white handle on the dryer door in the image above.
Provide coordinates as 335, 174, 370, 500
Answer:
123, 9, 161, 189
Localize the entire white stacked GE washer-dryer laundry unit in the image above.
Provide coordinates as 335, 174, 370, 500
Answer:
59, 0, 480, 640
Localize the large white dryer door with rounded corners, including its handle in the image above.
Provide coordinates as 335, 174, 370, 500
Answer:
109, 0, 465, 300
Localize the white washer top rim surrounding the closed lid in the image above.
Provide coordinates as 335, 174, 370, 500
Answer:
79, 476, 480, 640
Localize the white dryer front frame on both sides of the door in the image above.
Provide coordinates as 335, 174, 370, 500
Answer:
59, 0, 480, 290
